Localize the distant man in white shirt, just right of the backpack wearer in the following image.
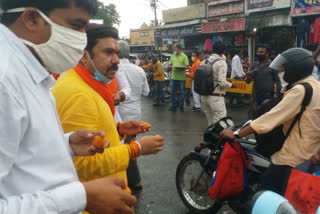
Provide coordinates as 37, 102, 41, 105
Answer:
230, 49, 245, 104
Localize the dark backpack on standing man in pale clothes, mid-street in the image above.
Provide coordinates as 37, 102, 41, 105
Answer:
194, 59, 222, 96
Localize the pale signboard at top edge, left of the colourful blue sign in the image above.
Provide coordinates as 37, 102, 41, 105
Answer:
247, 0, 291, 13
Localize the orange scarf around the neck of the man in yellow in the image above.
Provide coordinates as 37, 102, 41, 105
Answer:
74, 64, 115, 116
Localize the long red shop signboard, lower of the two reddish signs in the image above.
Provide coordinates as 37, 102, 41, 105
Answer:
202, 19, 246, 33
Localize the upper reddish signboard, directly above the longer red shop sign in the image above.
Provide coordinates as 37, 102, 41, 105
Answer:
208, 1, 244, 17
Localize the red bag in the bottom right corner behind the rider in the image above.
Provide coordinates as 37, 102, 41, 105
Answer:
285, 169, 320, 214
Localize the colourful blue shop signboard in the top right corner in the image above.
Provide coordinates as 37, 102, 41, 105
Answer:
292, 0, 320, 16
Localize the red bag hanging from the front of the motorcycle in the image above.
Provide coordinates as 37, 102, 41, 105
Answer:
208, 142, 249, 200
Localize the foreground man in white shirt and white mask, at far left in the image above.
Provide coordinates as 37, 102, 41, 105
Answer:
0, 0, 136, 214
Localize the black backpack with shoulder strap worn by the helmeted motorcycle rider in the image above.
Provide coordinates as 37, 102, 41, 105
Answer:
253, 83, 313, 157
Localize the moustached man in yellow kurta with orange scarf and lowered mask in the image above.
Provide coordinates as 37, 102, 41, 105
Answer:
53, 24, 164, 187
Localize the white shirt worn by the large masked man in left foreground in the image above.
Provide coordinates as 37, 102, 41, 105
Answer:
0, 25, 86, 214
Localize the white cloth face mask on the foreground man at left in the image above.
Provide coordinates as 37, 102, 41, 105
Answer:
6, 8, 87, 74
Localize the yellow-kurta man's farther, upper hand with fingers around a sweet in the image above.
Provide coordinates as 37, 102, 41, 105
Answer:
119, 120, 151, 135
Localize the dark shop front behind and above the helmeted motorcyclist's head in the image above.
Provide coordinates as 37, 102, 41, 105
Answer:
246, 0, 296, 62
